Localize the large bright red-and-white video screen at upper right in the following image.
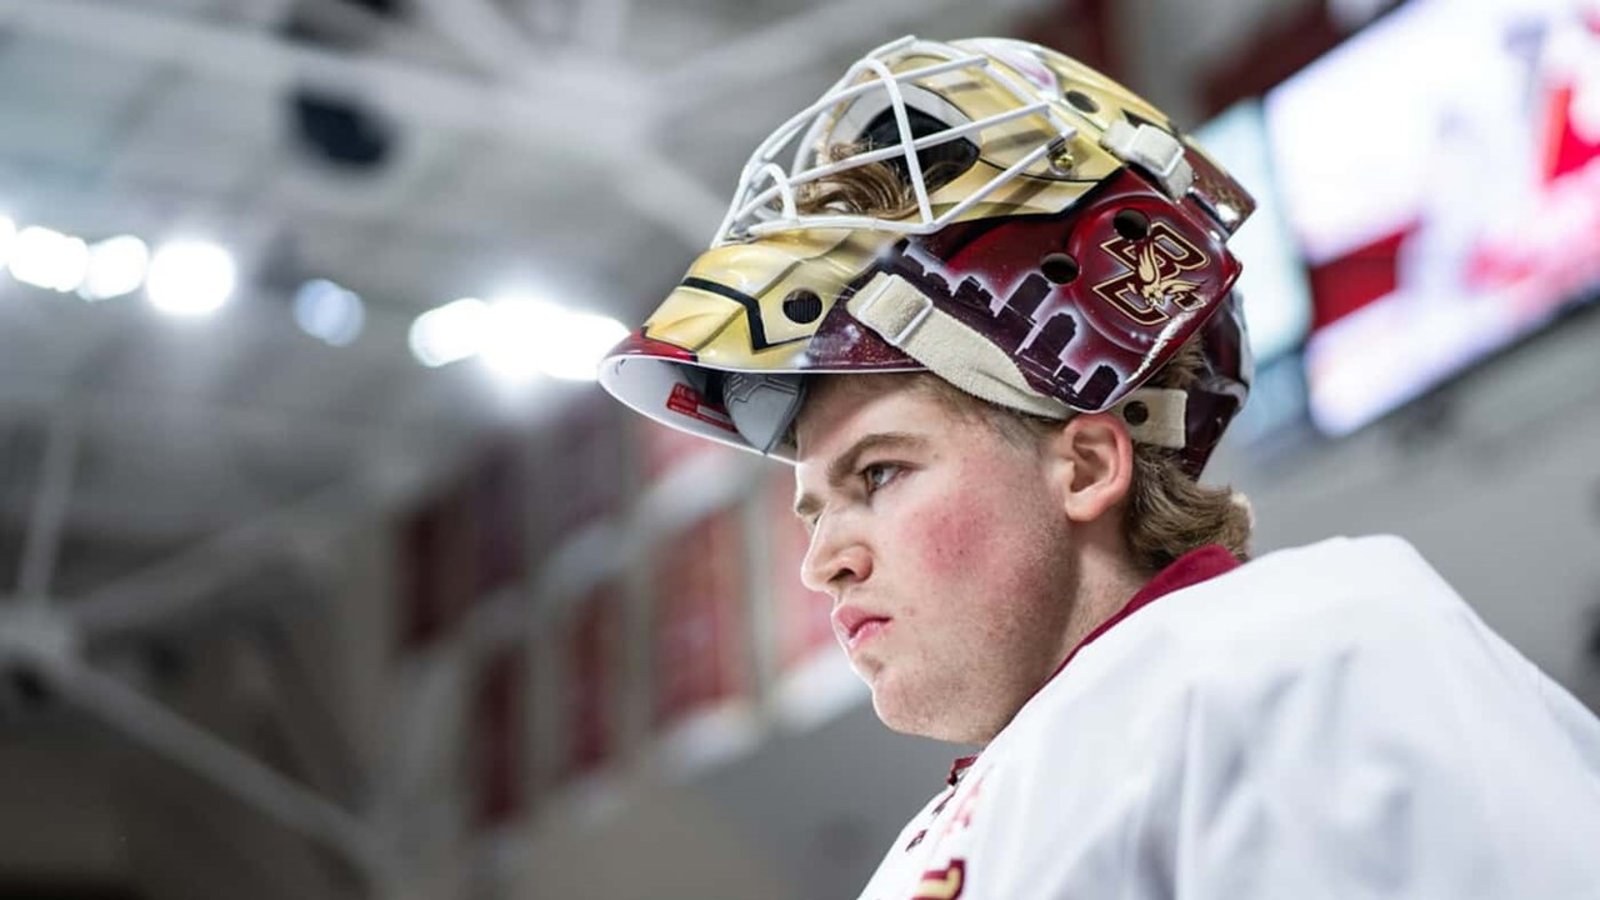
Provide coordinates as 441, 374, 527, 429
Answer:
1246, 0, 1600, 436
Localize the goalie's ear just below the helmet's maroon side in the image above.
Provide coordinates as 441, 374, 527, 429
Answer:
1046, 413, 1133, 524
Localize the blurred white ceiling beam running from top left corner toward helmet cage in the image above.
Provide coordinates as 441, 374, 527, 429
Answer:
0, 0, 725, 245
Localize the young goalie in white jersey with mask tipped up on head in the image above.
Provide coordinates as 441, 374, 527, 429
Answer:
602, 38, 1600, 900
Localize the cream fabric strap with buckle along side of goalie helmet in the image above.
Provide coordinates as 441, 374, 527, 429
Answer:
851, 272, 1189, 450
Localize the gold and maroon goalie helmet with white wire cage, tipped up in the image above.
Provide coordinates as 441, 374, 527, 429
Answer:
600, 37, 1253, 476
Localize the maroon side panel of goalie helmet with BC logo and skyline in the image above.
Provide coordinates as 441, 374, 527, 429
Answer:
814, 171, 1238, 410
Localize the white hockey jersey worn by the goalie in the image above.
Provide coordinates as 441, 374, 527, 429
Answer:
861, 536, 1600, 900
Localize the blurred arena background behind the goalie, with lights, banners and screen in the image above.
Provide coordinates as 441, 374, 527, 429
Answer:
0, 0, 1600, 900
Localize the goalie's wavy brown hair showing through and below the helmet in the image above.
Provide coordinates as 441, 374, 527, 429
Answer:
797, 146, 1251, 573
